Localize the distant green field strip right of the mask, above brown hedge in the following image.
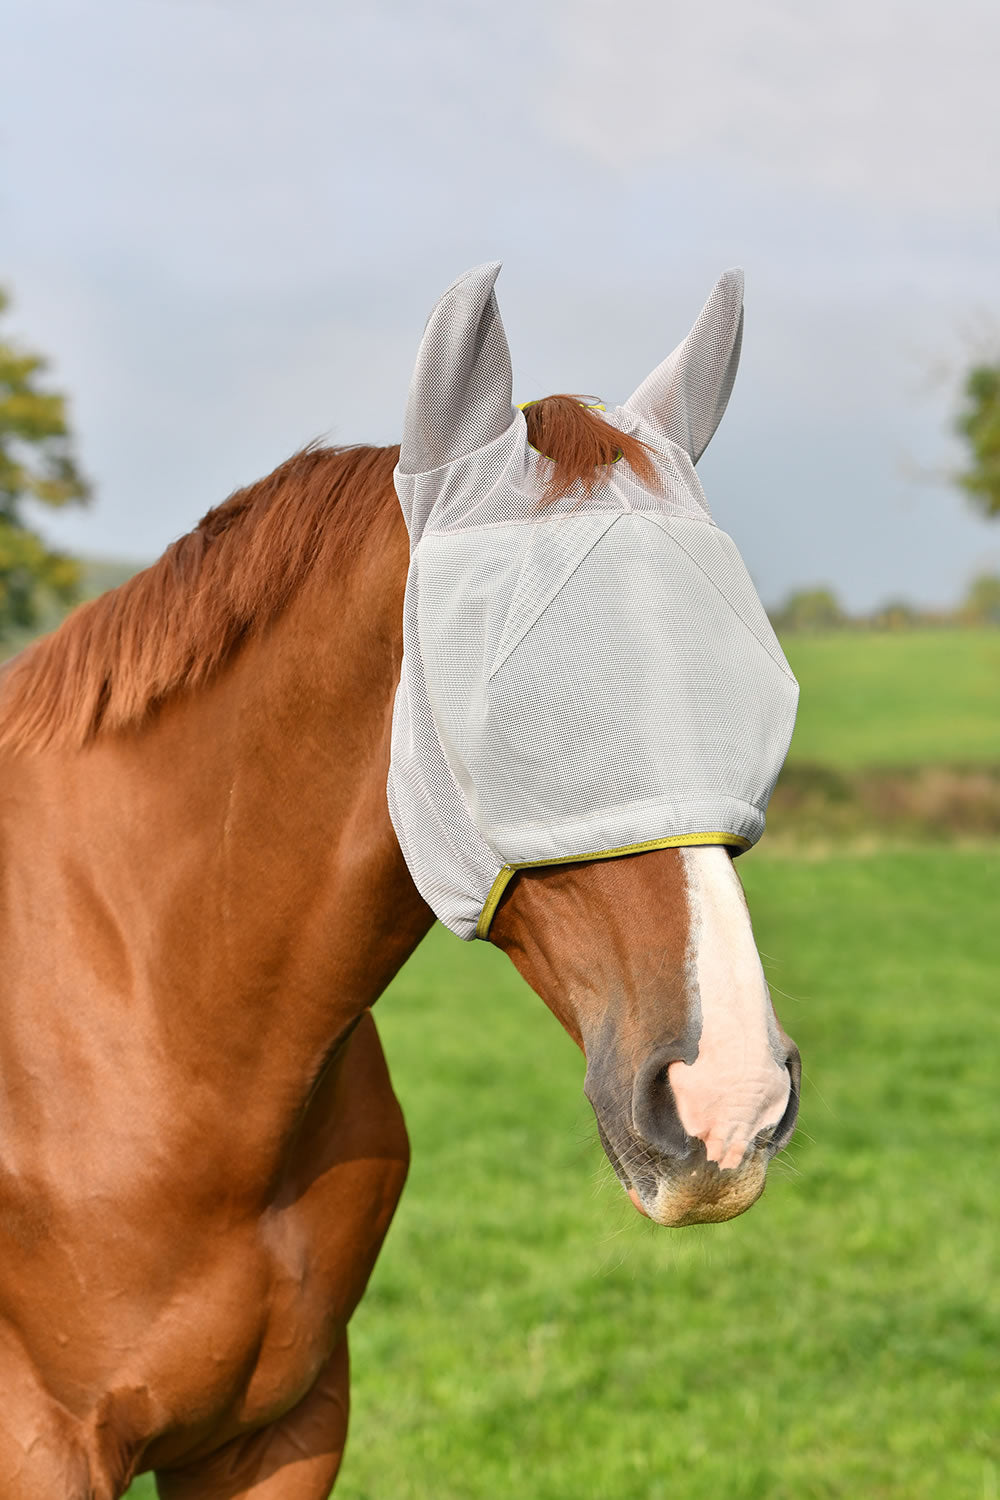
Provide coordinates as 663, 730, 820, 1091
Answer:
781, 629, 1000, 768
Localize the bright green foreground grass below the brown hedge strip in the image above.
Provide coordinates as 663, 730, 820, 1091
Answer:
125, 849, 1000, 1500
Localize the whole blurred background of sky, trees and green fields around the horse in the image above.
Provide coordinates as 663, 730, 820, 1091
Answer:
0, 0, 1000, 1500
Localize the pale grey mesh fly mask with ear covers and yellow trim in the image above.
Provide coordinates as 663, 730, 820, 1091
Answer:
388, 266, 798, 938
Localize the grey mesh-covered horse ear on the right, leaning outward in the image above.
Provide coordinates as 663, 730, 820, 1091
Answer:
625, 270, 744, 464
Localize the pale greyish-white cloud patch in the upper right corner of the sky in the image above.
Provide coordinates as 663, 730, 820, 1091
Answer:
549, 0, 1000, 225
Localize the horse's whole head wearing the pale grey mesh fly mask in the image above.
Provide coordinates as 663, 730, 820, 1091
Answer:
388, 266, 799, 1224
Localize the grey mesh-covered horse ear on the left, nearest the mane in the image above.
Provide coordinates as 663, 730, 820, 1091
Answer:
399, 261, 514, 474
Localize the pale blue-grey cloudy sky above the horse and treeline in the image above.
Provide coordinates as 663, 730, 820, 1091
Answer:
0, 0, 1000, 611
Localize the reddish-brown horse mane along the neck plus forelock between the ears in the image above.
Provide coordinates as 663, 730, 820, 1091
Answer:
0, 396, 654, 750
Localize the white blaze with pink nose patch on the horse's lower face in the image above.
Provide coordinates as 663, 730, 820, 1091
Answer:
669, 846, 790, 1167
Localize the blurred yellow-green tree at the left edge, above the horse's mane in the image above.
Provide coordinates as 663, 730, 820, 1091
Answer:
0, 291, 90, 639
